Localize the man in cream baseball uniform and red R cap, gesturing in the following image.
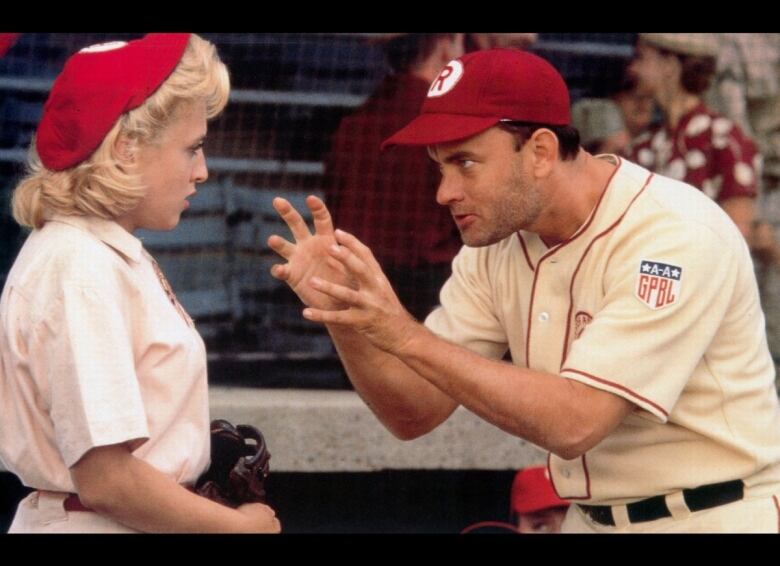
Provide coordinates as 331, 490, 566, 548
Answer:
269, 49, 780, 532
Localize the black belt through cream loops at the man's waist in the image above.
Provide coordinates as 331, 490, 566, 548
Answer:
579, 480, 745, 526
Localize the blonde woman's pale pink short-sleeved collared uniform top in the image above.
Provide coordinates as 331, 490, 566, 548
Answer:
0, 216, 210, 492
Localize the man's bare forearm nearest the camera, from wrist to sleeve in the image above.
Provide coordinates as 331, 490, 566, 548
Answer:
390, 325, 634, 458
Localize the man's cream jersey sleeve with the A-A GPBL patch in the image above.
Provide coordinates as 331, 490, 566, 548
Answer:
561, 223, 738, 422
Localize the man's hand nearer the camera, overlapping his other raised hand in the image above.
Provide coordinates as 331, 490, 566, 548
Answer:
303, 230, 418, 354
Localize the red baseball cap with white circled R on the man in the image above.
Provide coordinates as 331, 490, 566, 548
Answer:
381, 49, 571, 149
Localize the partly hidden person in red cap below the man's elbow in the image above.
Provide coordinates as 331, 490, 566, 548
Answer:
510, 466, 569, 534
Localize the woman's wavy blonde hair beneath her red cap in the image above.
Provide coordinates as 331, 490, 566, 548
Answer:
12, 34, 230, 228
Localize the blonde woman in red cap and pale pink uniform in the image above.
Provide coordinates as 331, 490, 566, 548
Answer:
0, 34, 280, 532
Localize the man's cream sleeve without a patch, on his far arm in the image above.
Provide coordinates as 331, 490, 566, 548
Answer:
425, 247, 508, 359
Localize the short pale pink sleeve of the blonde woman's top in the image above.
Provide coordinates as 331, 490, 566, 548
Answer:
29, 285, 149, 467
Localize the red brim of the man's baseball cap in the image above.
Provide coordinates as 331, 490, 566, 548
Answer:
380, 114, 501, 151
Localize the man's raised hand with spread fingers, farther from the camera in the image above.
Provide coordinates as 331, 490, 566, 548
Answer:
268, 196, 357, 310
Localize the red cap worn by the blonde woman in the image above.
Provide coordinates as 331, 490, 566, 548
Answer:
35, 33, 190, 171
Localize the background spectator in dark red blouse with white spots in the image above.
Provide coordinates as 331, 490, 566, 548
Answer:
629, 33, 760, 238
